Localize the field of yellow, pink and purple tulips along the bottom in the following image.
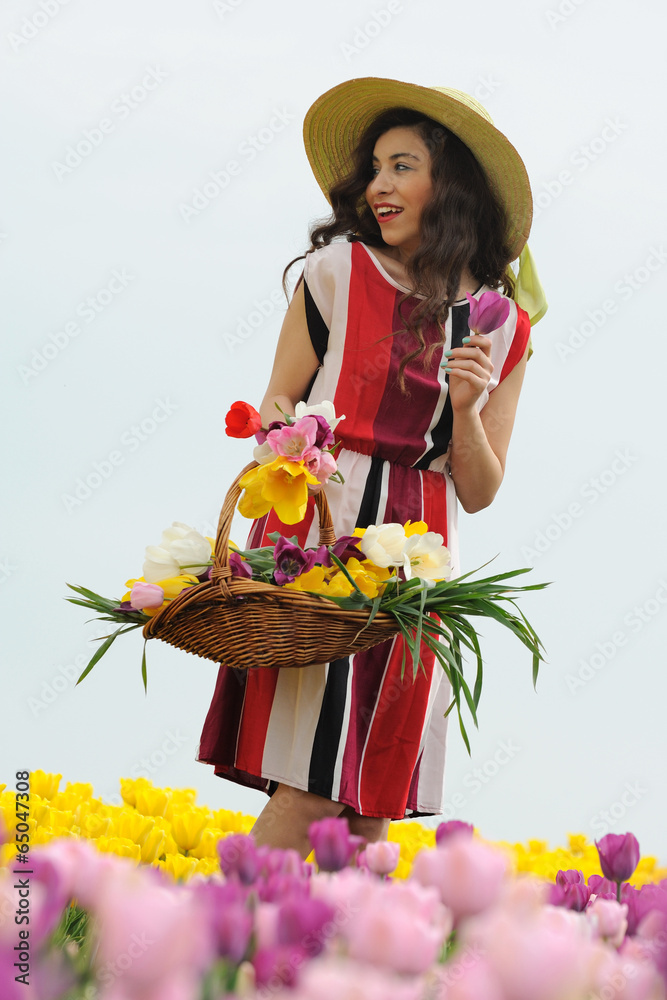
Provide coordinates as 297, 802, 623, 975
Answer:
0, 771, 667, 1000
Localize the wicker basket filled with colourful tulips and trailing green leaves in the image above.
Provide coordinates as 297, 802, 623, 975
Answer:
68, 402, 546, 750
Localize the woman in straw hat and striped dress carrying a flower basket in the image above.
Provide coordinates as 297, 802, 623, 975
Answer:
198, 79, 544, 857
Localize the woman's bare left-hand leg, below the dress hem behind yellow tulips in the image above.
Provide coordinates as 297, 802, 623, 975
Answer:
251, 784, 344, 858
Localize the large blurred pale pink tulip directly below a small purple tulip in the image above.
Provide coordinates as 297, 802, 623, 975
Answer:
412, 835, 507, 922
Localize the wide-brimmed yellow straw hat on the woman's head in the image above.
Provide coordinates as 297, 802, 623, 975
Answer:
303, 76, 533, 258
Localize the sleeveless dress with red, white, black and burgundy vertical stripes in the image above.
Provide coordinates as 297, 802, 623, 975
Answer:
197, 242, 530, 819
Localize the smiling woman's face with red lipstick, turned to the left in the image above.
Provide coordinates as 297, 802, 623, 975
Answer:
366, 127, 433, 257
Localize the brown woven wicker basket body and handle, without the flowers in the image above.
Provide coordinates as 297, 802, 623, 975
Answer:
143, 462, 399, 670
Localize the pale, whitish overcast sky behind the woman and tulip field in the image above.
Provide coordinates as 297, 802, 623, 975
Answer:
0, 0, 667, 861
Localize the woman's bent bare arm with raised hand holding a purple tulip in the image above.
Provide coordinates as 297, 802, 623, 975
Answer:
449, 335, 528, 514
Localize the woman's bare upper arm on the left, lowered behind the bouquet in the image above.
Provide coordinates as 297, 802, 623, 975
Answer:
259, 281, 320, 427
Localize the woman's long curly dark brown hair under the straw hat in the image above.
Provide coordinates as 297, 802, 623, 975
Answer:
283, 108, 514, 389
